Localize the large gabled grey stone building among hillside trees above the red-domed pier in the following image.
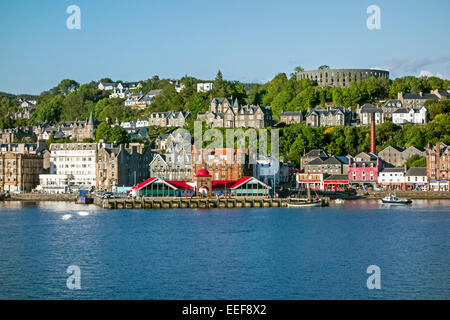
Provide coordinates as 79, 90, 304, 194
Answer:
197, 98, 272, 129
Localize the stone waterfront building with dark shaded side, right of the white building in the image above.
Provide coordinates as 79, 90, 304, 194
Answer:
95, 143, 152, 192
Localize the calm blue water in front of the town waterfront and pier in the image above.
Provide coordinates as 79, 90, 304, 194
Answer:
0, 201, 450, 299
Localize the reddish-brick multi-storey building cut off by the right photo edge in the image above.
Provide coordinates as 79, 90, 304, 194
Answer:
426, 142, 450, 191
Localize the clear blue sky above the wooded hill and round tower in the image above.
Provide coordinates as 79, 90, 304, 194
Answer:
0, 0, 450, 94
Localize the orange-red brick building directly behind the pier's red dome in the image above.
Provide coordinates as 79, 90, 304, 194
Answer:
191, 148, 254, 180
